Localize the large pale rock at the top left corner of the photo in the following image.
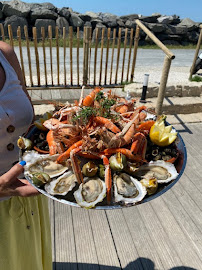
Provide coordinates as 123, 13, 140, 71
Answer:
2, 0, 30, 18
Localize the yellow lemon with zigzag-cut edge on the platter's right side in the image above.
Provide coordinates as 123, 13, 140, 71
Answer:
149, 116, 177, 146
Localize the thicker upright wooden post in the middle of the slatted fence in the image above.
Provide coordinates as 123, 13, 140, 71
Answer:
83, 27, 90, 85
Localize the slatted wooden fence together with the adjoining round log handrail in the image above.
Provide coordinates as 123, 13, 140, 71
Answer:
0, 20, 175, 114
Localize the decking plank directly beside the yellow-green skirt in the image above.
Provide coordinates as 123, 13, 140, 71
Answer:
55, 201, 77, 270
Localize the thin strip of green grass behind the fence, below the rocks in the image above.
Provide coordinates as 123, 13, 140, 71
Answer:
5, 37, 196, 50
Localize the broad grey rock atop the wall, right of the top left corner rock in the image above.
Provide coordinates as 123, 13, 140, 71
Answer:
30, 8, 58, 21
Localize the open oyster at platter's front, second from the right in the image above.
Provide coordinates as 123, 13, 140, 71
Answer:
114, 173, 147, 204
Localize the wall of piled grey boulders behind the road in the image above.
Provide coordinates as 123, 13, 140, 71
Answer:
0, 0, 200, 45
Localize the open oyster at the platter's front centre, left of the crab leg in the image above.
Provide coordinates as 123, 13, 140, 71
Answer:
74, 177, 106, 209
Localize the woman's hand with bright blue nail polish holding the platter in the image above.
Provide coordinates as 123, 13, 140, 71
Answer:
0, 163, 39, 197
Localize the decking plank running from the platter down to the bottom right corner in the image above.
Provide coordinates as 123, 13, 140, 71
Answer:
151, 192, 201, 269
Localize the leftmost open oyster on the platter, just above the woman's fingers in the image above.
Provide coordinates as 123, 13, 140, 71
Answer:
23, 151, 68, 178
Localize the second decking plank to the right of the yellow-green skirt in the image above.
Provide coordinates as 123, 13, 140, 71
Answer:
72, 207, 99, 270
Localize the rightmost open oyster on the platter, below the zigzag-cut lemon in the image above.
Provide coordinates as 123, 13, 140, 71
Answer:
135, 160, 178, 184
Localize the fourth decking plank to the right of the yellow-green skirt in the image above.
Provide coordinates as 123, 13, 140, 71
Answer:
106, 209, 142, 270
